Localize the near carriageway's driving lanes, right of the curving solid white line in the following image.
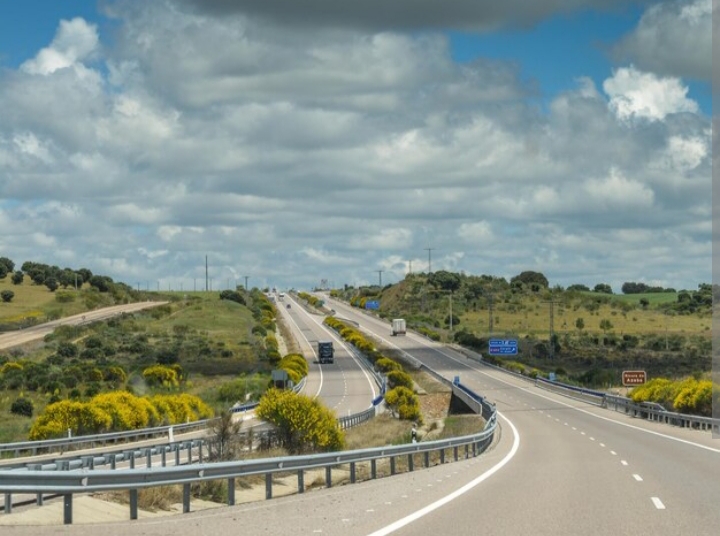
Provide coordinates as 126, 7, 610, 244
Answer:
328, 298, 720, 536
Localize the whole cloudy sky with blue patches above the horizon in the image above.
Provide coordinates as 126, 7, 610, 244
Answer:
0, 0, 712, 292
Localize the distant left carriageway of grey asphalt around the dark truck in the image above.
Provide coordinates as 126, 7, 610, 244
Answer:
278, 295, 379, 417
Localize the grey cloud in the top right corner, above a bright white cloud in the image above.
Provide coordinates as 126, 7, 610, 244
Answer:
614, 0, 713, 81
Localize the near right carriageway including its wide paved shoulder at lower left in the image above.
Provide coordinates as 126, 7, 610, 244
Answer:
2, 296, 720, 536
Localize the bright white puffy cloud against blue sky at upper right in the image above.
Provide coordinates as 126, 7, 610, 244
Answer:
603, 66, 698, 120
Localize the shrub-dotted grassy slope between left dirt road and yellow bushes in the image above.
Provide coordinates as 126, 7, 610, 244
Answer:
0, 285, 272, 442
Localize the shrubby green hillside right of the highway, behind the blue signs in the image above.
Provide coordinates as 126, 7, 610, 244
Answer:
335, 272, 712, 386
